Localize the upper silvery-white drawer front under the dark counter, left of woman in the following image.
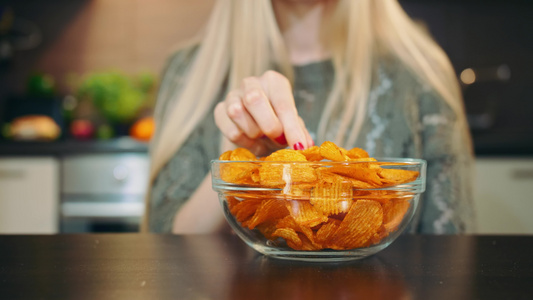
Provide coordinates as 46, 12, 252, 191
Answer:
61, 154, 149, 195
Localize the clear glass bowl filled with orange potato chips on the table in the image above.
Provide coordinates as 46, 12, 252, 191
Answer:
211, 159, 426, 261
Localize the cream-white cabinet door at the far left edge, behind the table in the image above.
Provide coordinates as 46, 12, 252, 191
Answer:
0, 157, 59, 234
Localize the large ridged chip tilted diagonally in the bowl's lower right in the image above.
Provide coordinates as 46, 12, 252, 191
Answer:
328, 200, 383, 250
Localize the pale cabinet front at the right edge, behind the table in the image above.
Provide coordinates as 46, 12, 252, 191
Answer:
474, 158, 533, 234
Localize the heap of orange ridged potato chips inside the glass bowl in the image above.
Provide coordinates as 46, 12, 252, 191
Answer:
219, 142, 419, 251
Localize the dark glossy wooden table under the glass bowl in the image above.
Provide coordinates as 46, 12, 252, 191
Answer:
0, 234, 533, 300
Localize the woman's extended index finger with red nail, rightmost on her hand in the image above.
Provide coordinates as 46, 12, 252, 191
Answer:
260, 71, 310, 150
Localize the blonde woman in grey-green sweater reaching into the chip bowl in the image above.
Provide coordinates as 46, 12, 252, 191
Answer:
143, 0, 474, 233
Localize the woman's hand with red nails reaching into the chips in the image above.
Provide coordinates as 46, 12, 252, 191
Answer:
215, 71, 314, 156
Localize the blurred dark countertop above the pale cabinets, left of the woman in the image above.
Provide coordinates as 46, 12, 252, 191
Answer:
0, 137, 148, 156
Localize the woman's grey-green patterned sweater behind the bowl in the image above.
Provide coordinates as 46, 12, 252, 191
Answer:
149, 48, 475, 234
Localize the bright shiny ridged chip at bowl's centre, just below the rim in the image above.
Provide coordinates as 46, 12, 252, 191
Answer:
309, 182, 353, 216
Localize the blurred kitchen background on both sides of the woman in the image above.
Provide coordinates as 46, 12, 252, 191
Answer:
0, 0, 533, 234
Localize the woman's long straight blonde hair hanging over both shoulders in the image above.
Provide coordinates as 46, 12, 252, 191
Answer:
142, 0, 468, 231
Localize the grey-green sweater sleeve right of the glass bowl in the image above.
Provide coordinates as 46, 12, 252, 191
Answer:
417, 92, 475, 234
